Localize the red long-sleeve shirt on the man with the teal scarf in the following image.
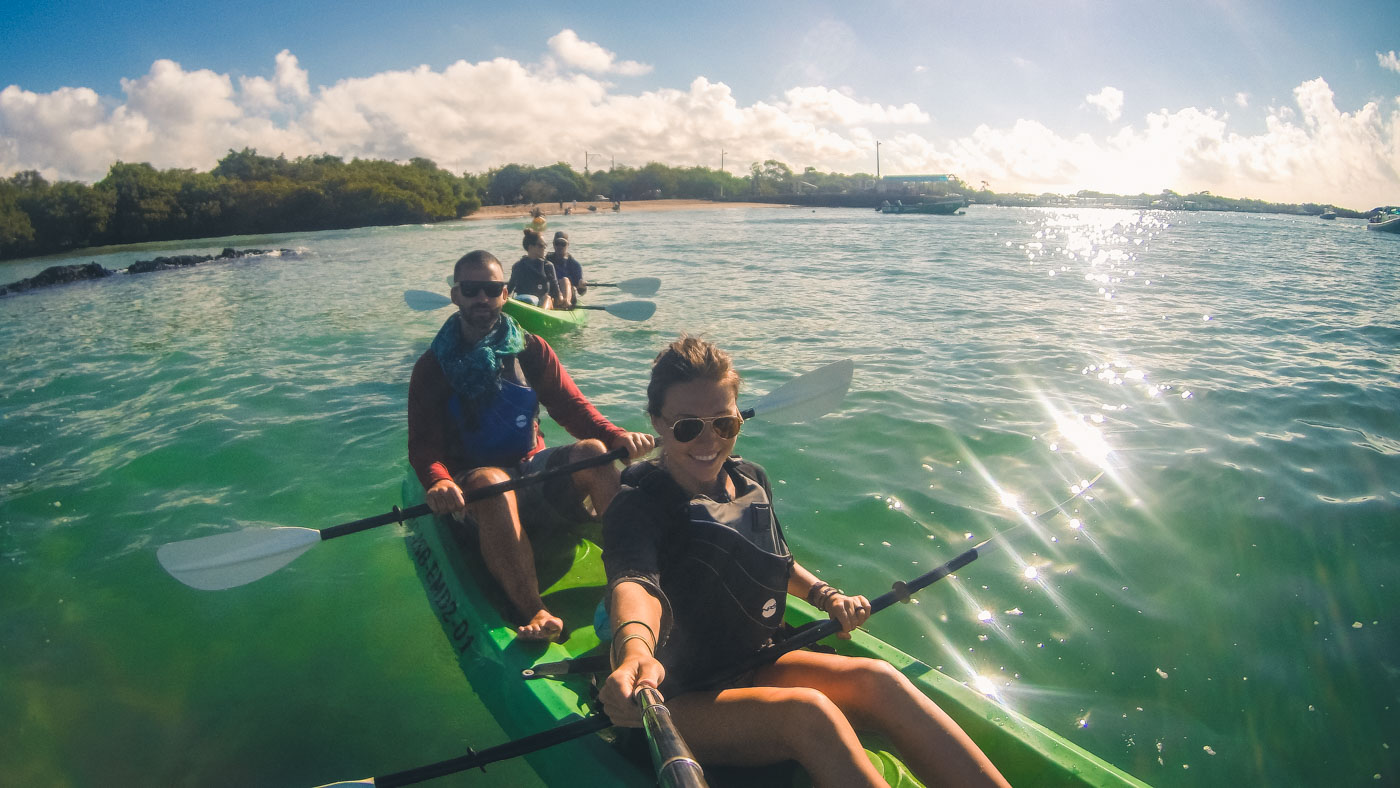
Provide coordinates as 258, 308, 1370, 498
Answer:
409, 335, 626, 490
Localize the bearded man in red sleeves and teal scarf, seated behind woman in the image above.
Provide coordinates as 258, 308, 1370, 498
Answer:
409, 251, 655, 640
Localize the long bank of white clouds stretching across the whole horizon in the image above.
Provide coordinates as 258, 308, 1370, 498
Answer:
0, 44, 1400, 207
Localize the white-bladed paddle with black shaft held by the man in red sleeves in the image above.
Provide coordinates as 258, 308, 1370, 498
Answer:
155, 358, 855, 591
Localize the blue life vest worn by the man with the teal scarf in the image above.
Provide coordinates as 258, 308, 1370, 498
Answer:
448, 356, 539, 467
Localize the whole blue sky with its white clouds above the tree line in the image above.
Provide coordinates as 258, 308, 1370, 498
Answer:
0, 0, 1400, 209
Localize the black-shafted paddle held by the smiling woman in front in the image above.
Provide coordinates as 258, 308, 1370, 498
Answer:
323, 539, 991, 788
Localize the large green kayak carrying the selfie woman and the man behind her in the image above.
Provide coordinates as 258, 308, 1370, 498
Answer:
403, 473, 1147, 788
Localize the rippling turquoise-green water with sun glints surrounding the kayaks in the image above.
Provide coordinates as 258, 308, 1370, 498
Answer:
0, 207, 1400, 787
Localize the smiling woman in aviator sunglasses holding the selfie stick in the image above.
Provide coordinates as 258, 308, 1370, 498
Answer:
601, 337, 1007, 787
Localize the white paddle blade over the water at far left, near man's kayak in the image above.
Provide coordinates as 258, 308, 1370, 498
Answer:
155, 528, 321, 591
